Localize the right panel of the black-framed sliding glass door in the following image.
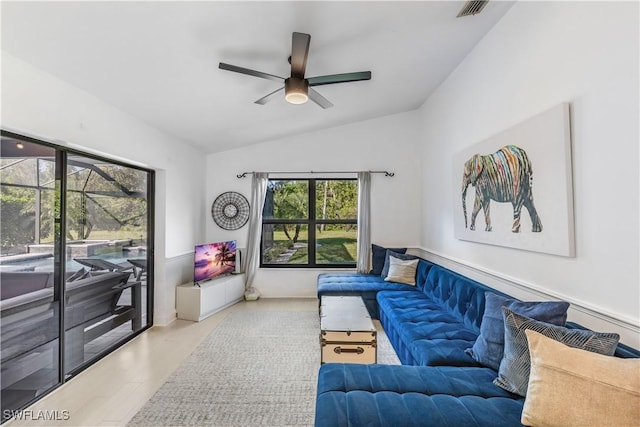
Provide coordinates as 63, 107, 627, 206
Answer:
65, 153, 150, 373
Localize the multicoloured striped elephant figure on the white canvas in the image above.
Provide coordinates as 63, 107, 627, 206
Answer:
462, 145, 542, 233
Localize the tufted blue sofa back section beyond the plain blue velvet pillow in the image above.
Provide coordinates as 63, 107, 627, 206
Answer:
423, 265, 493, 334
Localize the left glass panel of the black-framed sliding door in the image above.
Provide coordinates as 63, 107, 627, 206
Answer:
0, 140, 61, 421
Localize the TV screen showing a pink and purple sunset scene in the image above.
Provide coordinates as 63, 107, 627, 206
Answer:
193, 240, 236, 283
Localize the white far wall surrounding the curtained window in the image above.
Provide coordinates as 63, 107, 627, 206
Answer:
206, 110, 422, 297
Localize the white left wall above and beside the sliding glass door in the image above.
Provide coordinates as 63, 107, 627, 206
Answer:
1, 52, 205, 324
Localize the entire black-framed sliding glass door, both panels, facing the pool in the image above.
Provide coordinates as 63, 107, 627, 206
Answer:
0, 132, 153, 421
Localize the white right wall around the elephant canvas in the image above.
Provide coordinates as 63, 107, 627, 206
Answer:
420, 2, 640, 347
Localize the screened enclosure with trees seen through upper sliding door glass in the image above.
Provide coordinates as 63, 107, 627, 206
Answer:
0, 137, 147, 257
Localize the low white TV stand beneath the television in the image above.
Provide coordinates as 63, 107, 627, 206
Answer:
176, 273, 245, 322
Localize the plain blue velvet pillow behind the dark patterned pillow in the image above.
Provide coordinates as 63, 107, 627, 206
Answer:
466, 292, 569, 371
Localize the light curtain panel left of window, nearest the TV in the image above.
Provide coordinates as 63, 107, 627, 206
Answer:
244, 172, 269, 298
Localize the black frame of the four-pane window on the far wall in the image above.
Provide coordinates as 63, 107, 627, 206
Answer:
260, 178, 358, 270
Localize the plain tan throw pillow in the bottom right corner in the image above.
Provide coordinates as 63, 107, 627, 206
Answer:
521, 330, 640, 426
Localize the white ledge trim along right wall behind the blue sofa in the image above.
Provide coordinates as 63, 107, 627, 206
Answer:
410, 248, 640, 348
